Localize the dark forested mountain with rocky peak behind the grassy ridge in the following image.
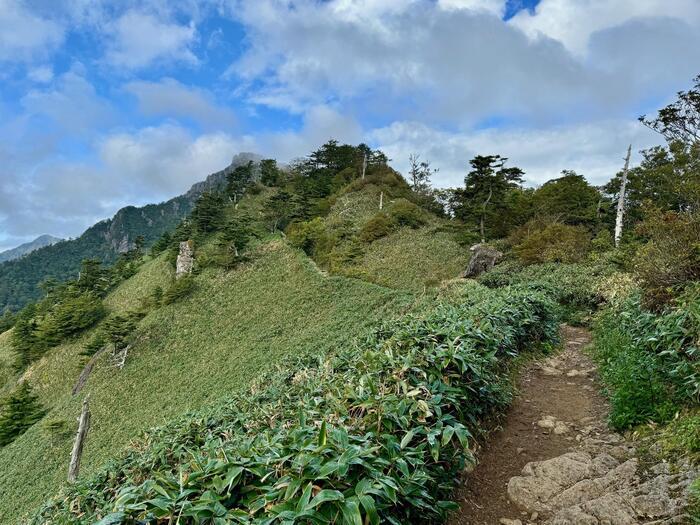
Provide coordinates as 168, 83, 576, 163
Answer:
0, 153, 262, 314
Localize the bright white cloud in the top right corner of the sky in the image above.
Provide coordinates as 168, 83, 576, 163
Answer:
509, 0, 700, 55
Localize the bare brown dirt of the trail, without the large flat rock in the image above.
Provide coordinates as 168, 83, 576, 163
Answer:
450, 326, 607, 525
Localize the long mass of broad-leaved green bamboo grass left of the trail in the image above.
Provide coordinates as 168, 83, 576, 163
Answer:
33, 284, 558, 524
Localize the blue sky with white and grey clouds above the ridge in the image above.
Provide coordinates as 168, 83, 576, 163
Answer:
0, 0, 700, 250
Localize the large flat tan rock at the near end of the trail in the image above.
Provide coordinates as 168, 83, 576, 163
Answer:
508, 434, 698, 525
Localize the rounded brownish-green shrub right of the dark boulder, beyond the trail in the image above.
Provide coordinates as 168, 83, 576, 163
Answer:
513, 223, 591, 264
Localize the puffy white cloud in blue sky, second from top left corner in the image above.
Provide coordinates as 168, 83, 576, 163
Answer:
106, 10, 198, 69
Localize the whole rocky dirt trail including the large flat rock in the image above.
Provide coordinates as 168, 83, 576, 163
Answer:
450, 326, 698, 525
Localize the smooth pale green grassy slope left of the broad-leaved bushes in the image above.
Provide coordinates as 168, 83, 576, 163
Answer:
0, 241, 413, 523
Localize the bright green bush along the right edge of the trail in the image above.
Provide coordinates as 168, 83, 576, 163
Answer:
594, 294, 700, 429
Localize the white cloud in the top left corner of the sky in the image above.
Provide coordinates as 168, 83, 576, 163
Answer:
0, 0, 64, 62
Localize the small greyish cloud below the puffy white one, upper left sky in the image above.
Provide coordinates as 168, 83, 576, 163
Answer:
125, 78, 236, 129
